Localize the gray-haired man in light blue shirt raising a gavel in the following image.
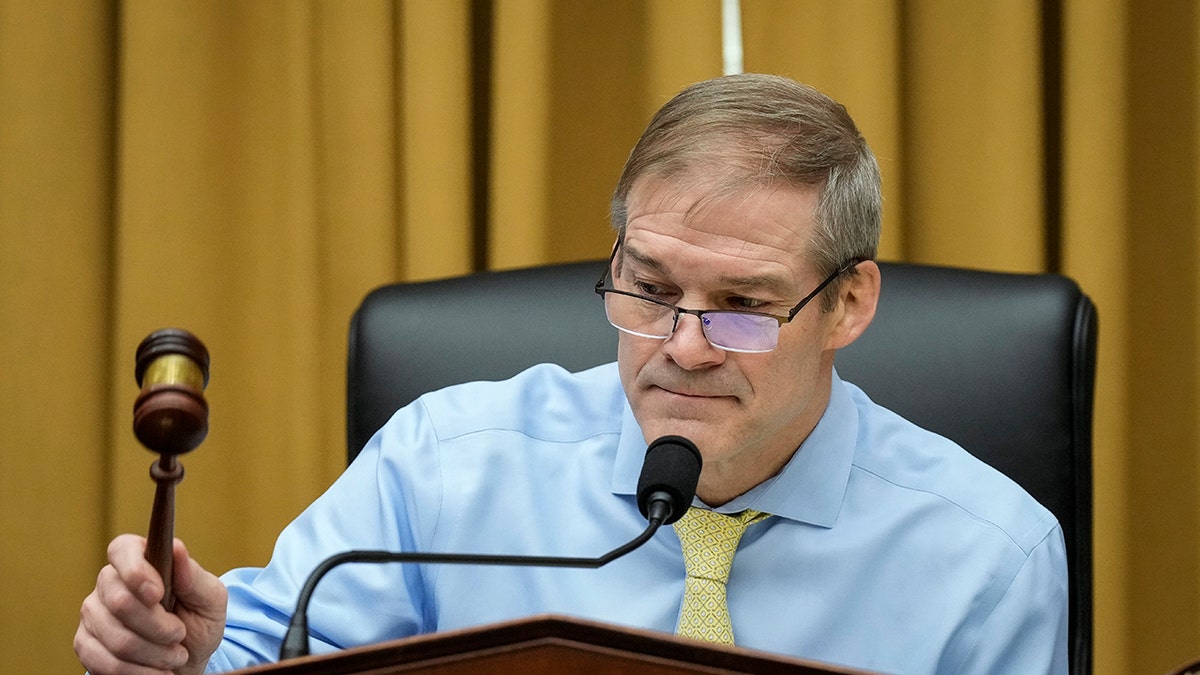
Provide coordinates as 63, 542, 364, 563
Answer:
76, 76, 1067, 674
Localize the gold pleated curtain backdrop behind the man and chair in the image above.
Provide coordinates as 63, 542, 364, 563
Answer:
0, 0, 1180, 675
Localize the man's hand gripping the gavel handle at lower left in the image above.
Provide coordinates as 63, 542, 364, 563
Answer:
74, 534, 228, 675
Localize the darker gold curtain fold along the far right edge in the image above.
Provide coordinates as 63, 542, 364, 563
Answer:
1124, 2, 1200, 668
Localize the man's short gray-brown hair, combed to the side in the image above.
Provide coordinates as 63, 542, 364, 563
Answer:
611, 73, 883, 309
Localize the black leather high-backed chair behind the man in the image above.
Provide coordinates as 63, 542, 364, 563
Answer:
347, 261, 1097, 675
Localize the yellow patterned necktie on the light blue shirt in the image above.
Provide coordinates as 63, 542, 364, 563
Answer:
674, 508, 767, 645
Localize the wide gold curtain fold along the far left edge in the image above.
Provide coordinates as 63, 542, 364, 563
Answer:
0, 1, 115, 673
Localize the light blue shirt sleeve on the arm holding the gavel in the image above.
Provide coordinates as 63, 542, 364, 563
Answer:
208, 402, 442, 673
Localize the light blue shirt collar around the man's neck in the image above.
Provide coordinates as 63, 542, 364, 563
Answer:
612, 371, 858, 527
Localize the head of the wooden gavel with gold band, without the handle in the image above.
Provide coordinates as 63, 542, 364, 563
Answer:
133, 328, 209, 455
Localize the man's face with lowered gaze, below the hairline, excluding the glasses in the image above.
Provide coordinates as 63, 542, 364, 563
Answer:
613, 178, 841, 506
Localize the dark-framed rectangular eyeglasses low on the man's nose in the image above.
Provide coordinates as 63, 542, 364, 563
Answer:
595, 240, 863, 353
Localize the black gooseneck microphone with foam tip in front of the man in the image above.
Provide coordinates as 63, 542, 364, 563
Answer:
280, 436, 701, 661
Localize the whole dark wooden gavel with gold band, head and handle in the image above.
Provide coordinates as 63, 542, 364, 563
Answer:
133, 328, 209, 611
